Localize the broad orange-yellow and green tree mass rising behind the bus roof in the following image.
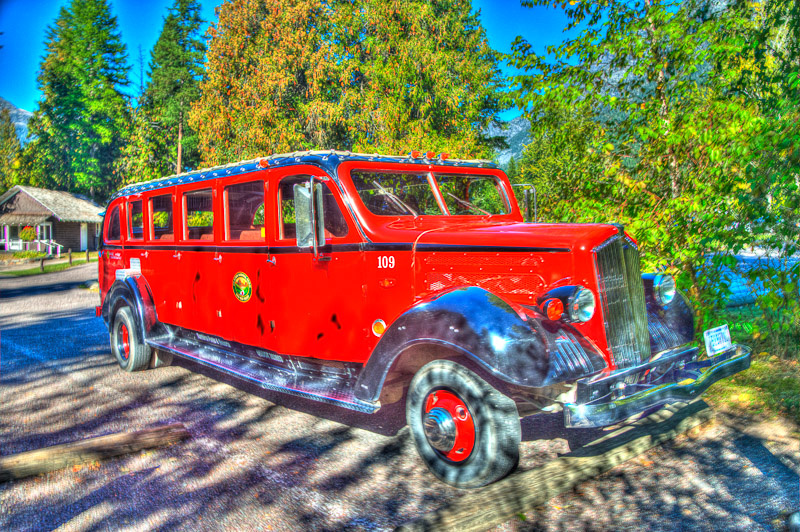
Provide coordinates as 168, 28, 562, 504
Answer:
191, 0, 502, 163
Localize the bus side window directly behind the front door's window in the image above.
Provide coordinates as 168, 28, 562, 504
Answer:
225, 181, 266, 241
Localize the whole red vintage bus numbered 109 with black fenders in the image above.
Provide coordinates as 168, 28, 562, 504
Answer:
98, 151, 750, 487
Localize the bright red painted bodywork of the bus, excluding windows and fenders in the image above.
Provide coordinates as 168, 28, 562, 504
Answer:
99, 161, 617, 367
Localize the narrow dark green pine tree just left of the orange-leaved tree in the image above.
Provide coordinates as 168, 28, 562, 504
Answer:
144, 0, 206, 173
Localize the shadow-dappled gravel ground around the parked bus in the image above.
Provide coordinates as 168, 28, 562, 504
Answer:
0, 264, 800, 530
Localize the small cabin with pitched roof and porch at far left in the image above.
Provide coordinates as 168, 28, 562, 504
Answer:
0, 185, 103, 255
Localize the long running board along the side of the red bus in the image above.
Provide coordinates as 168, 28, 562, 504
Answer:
147, 336, 380, 414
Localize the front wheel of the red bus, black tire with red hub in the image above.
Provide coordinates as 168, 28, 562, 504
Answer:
406, 360, 521, 488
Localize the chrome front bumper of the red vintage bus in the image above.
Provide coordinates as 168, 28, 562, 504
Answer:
564, 345, 750, 428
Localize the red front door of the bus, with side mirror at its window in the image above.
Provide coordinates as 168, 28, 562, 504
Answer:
264, 166, 366, 361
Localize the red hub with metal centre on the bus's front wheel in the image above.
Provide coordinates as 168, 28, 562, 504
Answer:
424, 390, 475, 462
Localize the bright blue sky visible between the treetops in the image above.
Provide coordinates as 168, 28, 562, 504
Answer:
0, 0, 566, 119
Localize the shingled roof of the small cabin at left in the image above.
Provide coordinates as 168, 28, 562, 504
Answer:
0, 185, 103, 223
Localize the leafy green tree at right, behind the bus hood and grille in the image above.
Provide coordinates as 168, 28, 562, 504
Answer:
510, 0, 797, 330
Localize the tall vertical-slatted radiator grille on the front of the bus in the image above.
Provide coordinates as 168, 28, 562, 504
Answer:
594, 235, 650, 368
